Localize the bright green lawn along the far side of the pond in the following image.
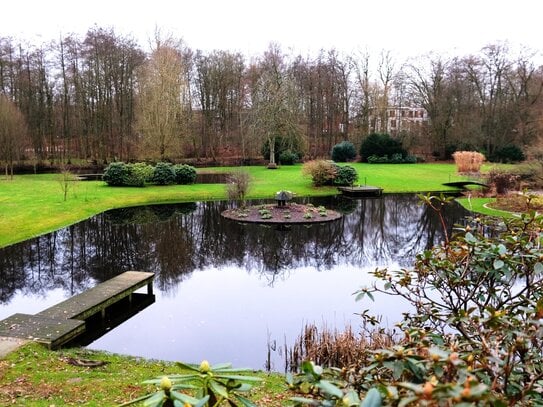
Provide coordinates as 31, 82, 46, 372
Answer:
0, 163, 476, 247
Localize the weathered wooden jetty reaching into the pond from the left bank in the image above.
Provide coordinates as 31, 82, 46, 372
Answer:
0, 271, 154, 349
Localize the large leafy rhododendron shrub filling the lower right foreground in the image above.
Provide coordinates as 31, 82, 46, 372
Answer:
353, 202, 543, 406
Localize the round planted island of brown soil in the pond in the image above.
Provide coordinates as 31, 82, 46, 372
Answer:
222, 203, 341, 225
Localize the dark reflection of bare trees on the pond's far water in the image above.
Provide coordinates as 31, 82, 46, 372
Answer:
0, 195, 470, 303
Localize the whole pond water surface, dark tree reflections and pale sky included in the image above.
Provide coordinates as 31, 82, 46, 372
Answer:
0, 195, 466, 370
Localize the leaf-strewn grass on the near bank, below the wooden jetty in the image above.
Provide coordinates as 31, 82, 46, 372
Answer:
0, 343, 290, 407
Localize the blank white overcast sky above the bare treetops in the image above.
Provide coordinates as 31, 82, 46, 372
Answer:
0, 0, 543, 58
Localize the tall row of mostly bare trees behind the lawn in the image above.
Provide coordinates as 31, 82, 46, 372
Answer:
0, 27, 543, 174
